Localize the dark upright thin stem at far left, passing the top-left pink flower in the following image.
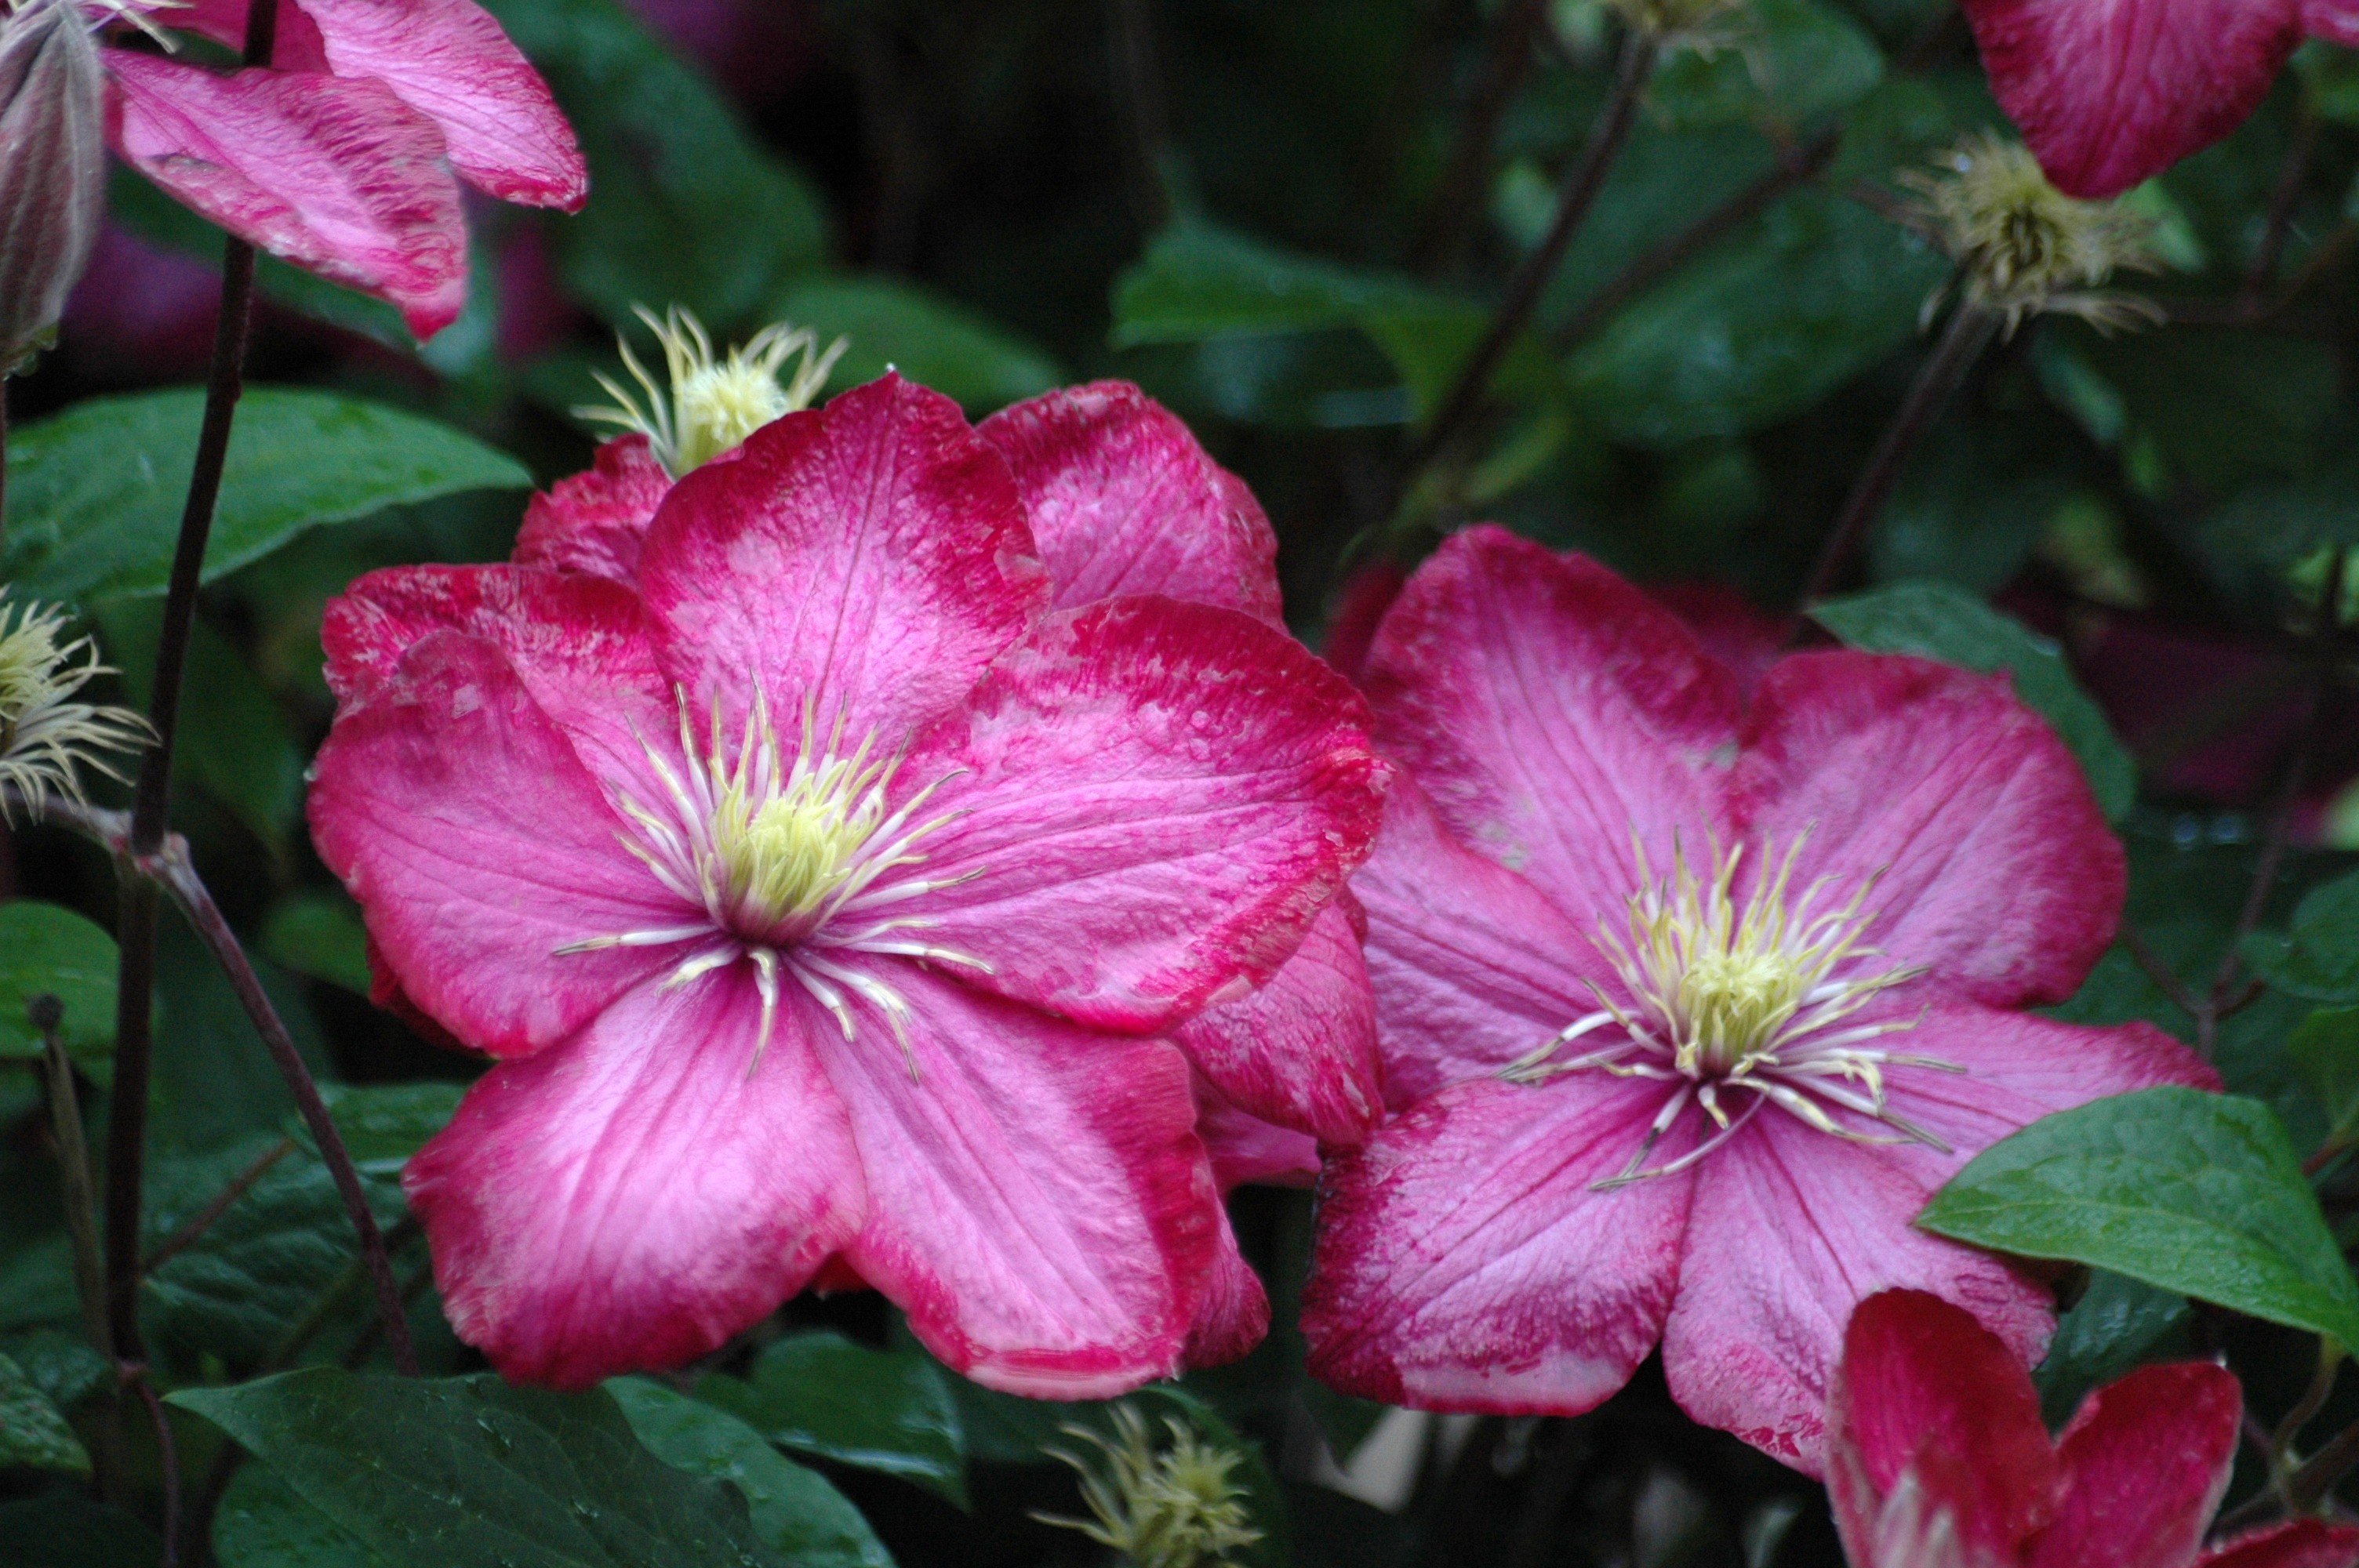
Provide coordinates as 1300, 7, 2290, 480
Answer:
106, 5, 278, 1358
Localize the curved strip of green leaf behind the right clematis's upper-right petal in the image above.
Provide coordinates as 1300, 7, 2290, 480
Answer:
1809, 583, 2137, 823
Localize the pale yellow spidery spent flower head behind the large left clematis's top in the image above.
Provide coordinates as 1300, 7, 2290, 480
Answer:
573, 304, 847, 479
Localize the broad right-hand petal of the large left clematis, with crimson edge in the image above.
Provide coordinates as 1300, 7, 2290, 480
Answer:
903, 597, 1390, 1028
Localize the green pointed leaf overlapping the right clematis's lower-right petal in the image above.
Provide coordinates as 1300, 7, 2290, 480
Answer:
1918, 1087, 2359, 1344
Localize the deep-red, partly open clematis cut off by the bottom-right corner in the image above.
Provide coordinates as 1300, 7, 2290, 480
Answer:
1826, 1290, 2359, 1568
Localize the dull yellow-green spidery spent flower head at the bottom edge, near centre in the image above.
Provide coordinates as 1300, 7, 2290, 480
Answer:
1034, 1405, 1262, 1568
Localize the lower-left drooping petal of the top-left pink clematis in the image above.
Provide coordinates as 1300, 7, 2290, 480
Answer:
106, 49, 467, 337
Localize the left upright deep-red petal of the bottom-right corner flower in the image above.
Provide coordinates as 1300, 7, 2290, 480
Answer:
1826, 1290, 2062, 1563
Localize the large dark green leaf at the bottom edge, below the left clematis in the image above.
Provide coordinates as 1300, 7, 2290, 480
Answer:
170, 1367, 788, 1568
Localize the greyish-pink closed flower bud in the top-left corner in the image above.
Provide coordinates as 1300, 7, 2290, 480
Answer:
0, 0, 106, 375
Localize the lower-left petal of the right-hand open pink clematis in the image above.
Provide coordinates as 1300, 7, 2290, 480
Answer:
1302, 1075, 1694, 1415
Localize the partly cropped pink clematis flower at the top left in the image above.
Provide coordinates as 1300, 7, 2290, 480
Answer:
89, 0, 590, 337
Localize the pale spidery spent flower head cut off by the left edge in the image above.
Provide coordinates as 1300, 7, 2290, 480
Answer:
0, 590, 151, 821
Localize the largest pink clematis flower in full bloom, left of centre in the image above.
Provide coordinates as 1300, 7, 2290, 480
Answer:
311, 377, 1387, 1396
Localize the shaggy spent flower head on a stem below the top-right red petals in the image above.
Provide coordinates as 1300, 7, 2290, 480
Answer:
1901, 134, 2163, 332
